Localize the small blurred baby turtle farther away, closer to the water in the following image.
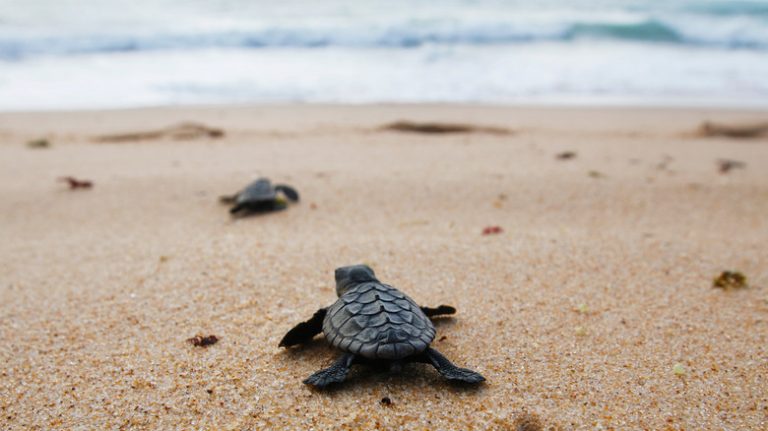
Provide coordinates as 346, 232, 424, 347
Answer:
219, 178, 299, 215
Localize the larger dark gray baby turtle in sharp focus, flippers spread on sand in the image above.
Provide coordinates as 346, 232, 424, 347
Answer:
280, 265, 485, 388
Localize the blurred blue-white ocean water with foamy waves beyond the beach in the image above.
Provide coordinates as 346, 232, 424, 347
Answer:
0, 0, 768, 110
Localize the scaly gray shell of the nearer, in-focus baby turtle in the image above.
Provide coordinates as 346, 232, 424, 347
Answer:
323, 282, 435, 360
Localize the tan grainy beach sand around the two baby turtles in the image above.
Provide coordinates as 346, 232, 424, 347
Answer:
0, 106, 768, 430
